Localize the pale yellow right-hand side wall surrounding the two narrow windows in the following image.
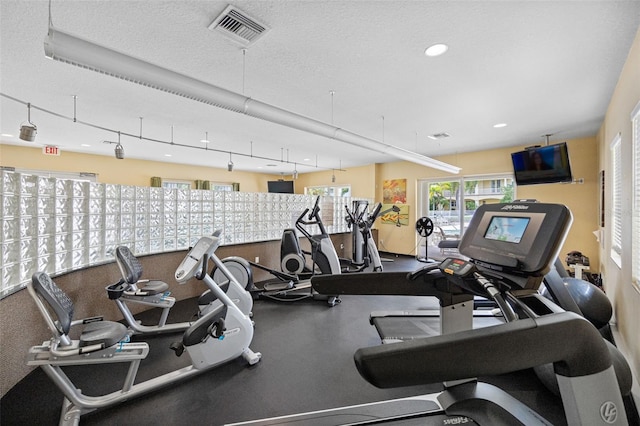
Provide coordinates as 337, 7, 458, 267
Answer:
598, 29, 640, 380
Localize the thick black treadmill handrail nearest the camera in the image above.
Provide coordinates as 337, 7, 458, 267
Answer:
354, 312, 611, 388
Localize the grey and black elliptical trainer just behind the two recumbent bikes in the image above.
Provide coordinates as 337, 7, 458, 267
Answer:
212, 197, 341, 306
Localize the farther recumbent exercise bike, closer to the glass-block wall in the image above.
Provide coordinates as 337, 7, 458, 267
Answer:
106, 230, 253, 334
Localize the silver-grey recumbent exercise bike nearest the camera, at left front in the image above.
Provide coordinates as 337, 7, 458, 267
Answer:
27, 236, 261, 425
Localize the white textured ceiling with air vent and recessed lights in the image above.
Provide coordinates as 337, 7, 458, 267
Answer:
0, 0, 640, 174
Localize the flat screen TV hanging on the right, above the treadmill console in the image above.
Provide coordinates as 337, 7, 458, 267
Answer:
511, 142, 573, 185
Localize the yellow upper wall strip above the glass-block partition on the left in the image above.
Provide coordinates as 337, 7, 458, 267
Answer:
0, 144, 278, 192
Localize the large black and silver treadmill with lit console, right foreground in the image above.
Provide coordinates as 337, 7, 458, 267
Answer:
231, 203, 638, 426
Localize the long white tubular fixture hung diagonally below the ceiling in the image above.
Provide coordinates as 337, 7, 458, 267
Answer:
44, 26, 460, 173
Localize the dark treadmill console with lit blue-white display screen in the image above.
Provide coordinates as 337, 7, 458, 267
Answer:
459, 202, 572, 276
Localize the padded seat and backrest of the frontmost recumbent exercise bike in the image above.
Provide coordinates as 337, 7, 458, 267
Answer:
31, 272, 128, 347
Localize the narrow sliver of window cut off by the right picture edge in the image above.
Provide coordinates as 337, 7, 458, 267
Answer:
631, 102, 640, 290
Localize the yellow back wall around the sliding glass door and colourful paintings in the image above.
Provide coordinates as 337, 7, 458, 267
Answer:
304, 137, 599, 272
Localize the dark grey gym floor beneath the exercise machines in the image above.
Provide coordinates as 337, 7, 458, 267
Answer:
0, 258, 564, 425
